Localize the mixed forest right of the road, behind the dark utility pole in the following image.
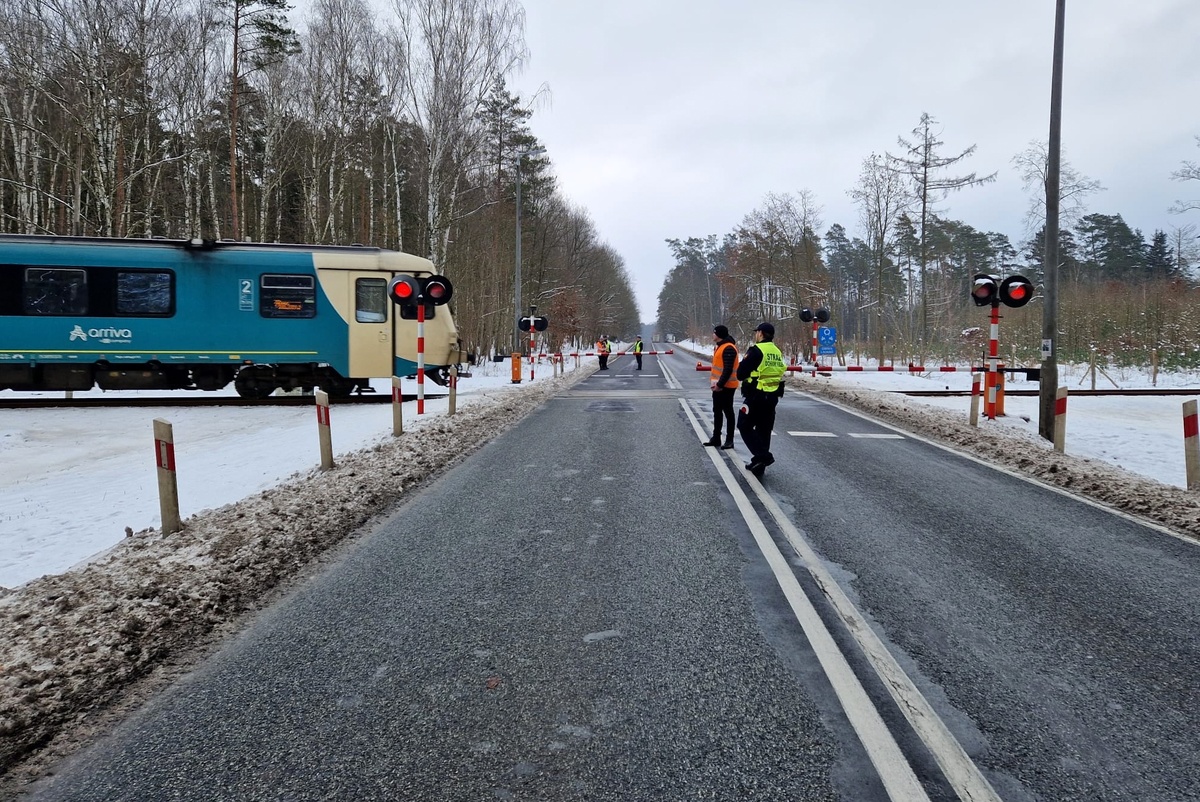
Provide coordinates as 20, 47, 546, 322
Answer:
658, 114, 1200, 369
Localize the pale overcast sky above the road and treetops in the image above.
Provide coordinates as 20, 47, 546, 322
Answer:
511, 0, 1200, 322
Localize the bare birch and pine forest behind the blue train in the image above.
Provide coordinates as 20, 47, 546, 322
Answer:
0, 0, 640, 355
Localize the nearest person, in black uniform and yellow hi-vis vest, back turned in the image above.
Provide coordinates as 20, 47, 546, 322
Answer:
738, 322, 787, 479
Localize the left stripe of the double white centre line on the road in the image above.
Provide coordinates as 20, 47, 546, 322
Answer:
679, 399, 926, 802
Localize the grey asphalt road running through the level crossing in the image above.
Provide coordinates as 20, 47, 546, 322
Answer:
25, 355, 1200, 802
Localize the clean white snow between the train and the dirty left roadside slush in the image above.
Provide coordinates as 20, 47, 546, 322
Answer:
0, 359, 587, 587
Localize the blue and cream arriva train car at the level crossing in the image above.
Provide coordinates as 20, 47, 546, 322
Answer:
0, 235, 463, 397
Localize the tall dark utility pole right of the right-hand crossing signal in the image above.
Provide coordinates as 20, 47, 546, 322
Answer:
1038, 0, 1067, 443
